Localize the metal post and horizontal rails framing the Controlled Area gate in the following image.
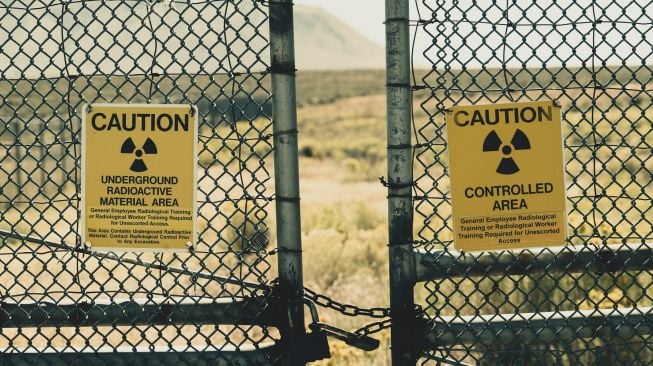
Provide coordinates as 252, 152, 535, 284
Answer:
385, 0, 653, 366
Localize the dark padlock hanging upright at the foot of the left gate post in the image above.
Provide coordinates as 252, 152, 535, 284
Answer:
288, 301, 331, 363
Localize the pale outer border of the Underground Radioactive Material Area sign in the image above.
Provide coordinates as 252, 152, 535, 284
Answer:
78, 103, 200, 253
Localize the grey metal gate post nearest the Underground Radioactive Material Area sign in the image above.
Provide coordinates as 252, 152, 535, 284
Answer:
269, 0, 305, 365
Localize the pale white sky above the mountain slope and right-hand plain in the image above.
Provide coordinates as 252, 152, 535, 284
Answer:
295, 0, 653, 68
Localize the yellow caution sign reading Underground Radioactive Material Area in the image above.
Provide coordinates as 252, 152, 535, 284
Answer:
82, 104, 197, 251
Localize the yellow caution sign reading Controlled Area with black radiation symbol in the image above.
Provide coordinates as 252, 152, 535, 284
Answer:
447, 101, 567, 251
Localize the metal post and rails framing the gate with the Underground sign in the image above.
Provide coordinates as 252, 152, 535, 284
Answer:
0, 0, 306, 366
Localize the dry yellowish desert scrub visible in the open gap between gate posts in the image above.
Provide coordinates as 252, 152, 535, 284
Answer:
298, 84, 390, 366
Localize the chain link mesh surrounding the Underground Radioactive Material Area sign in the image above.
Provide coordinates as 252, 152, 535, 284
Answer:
0, 0, 278, 363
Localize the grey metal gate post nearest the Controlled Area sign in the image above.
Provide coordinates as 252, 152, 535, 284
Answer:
385, 0, 417, 365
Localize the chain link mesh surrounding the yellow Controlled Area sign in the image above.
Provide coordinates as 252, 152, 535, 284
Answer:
412, 0, 653, 365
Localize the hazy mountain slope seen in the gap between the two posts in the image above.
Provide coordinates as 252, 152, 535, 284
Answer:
295, 6, 385, 70
